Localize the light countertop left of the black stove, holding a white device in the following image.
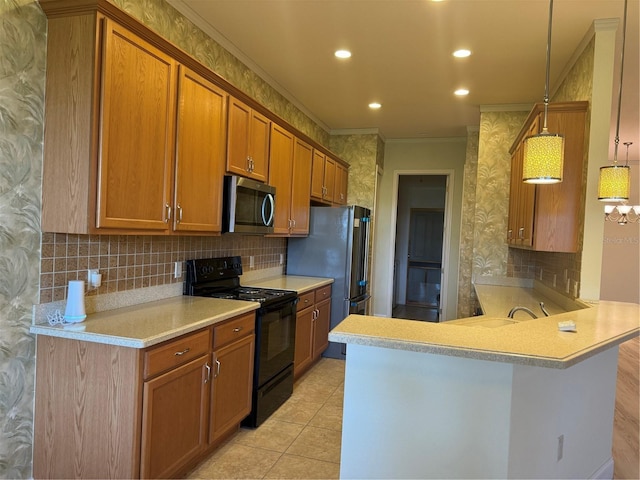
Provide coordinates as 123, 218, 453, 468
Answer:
30, 296, 260, 348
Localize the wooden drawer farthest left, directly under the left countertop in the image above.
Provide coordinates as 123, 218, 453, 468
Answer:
144, 328, 211, 379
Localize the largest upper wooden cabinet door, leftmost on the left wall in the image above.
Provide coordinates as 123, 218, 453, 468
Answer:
96, 19, 176, 231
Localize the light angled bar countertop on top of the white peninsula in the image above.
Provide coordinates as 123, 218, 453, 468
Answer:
329, 302, 640, 368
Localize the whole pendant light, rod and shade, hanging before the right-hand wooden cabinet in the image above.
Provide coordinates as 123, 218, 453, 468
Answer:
522, 0, 564, 184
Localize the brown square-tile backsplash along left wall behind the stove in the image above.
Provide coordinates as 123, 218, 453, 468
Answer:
40, 233, 287, 304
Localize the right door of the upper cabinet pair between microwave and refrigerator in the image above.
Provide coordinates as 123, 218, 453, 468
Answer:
291, 139, 313, 235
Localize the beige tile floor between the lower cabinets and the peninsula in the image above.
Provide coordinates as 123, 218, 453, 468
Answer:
187, 358, 344, 479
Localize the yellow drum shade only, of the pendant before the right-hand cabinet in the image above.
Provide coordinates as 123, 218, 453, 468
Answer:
522, 131, 564, 184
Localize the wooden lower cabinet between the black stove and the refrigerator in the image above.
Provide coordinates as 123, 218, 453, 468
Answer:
293, 285, 331, 379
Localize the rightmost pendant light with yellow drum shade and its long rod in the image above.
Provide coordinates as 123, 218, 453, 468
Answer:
598, 0, 631, 202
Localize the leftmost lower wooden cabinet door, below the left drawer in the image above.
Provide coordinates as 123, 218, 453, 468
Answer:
141, 355, 209, 478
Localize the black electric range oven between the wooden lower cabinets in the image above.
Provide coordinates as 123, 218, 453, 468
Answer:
184, 256, 298, 427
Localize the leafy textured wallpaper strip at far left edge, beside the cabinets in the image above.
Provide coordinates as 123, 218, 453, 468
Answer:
0, 0, 46, 478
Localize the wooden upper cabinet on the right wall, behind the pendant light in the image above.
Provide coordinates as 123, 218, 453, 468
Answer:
507, 102, 588, 253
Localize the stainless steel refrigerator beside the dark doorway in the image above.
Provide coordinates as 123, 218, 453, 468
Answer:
287, 205, 371, 358
